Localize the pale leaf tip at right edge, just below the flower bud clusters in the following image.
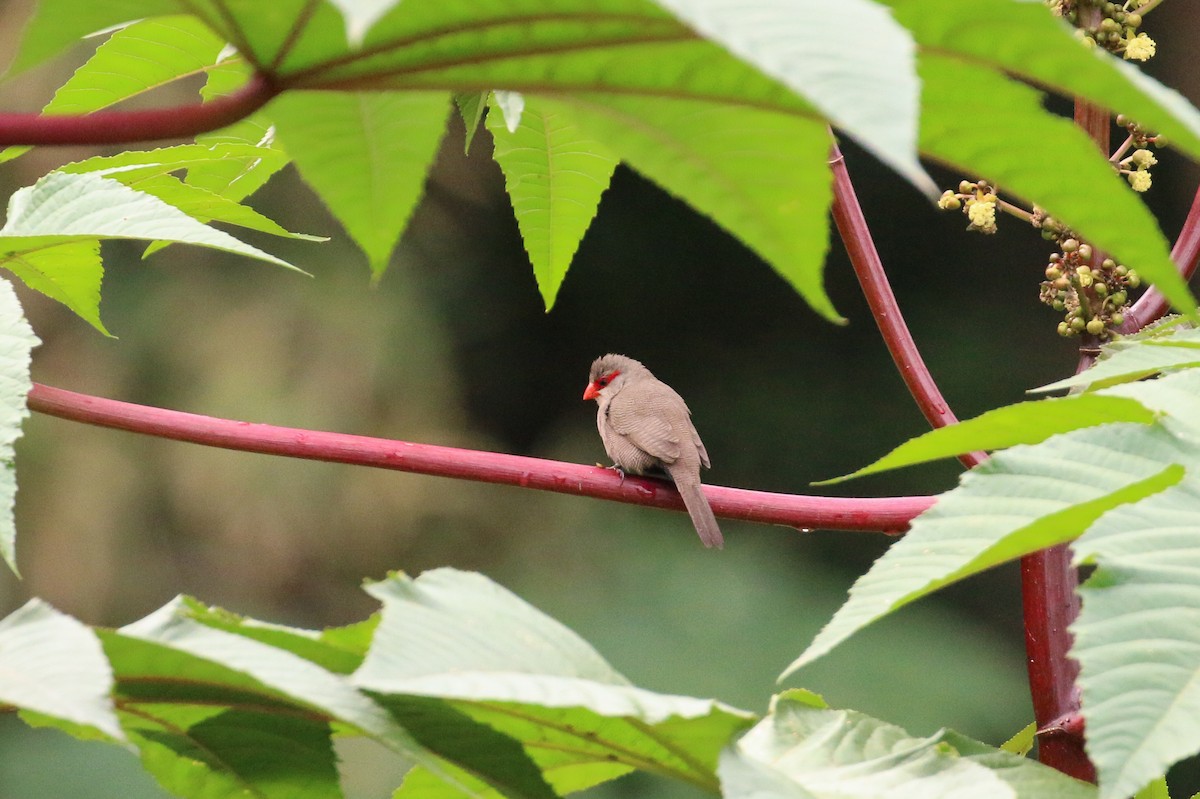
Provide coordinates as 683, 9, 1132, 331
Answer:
1033, 328, 1200, 391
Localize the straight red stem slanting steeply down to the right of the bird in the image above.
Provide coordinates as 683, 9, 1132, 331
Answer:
829, 144, 988, 469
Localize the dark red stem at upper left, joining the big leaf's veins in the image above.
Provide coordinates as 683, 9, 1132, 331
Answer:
0, 74, 278, 145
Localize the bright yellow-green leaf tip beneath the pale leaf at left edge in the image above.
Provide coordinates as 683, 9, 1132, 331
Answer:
0, 238, 109, 336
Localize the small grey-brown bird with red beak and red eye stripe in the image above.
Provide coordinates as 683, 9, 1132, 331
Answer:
583, 354, 725, 548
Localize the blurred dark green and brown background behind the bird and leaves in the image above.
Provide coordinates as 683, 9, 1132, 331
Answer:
0, 0, 1200, 799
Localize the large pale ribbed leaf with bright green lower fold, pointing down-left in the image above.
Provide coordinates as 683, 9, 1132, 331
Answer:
784, 372, 1200, 677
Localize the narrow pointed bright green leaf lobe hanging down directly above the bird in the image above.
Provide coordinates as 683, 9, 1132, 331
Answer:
487, 98, 617, 311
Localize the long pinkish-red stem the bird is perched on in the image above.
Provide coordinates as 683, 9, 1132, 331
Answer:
29, 384, 934, 534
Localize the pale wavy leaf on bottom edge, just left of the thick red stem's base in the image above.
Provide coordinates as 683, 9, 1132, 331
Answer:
720, 695, 1096, 799
